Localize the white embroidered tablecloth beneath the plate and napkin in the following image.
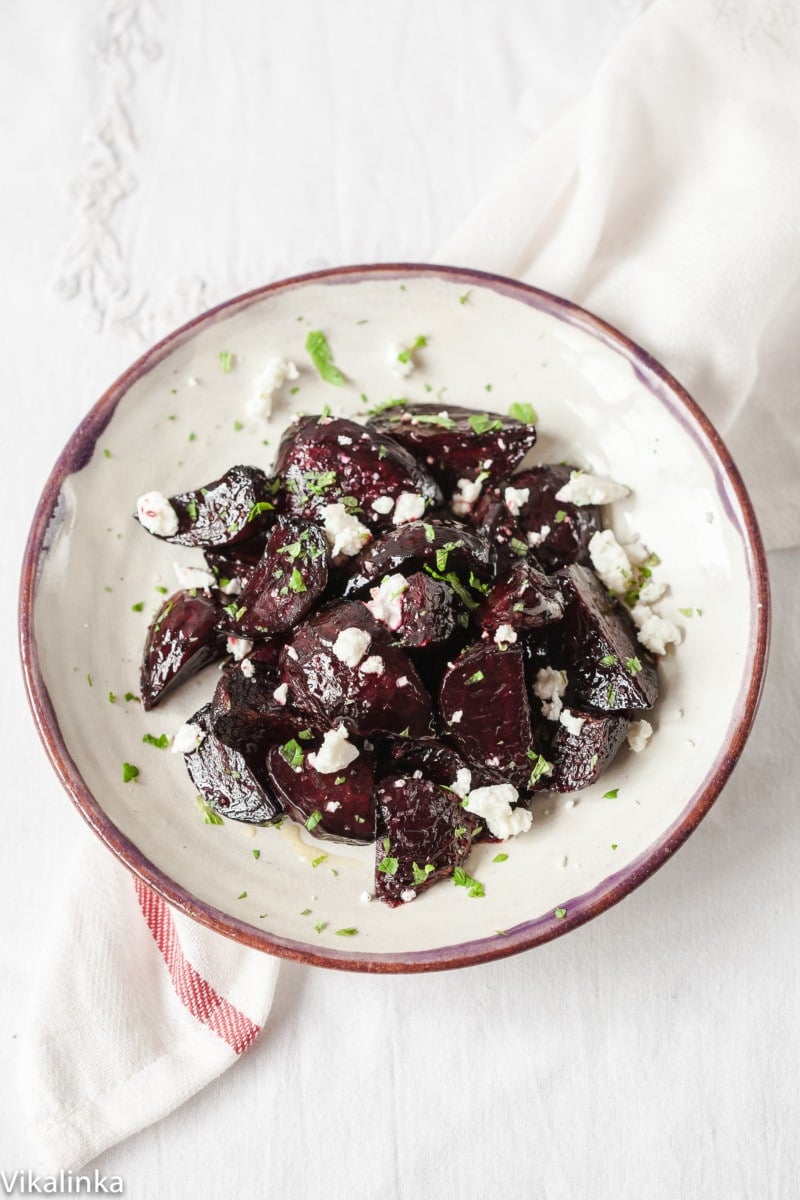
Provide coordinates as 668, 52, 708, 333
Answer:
0, 0, 800, 1200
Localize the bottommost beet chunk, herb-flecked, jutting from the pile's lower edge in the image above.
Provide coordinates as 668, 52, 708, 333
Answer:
375, 775, 475, 908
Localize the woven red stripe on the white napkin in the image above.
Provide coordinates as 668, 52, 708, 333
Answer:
133, 880, 260, 1054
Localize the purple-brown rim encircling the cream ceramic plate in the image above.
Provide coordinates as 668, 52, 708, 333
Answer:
18, 263, 771, 974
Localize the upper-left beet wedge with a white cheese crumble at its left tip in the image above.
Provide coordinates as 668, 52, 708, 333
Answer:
136, 467, 276, 547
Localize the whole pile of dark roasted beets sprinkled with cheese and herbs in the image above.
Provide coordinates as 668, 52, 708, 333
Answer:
136, 403, 657, 905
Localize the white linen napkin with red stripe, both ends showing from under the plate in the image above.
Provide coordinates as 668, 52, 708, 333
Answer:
22, 0, 800, 1169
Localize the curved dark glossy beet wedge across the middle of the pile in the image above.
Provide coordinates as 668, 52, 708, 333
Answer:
344, 521, 495, 596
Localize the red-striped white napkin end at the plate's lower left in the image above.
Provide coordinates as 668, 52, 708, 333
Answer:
20, 839, 279, 1172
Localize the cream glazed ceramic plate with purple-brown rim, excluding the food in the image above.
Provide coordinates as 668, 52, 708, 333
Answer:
20, 264, 769, 972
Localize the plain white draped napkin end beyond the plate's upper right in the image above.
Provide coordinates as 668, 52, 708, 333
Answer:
438, 0, 800, 547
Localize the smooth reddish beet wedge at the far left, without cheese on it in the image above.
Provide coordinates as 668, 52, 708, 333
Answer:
139, 589, 224, 709
